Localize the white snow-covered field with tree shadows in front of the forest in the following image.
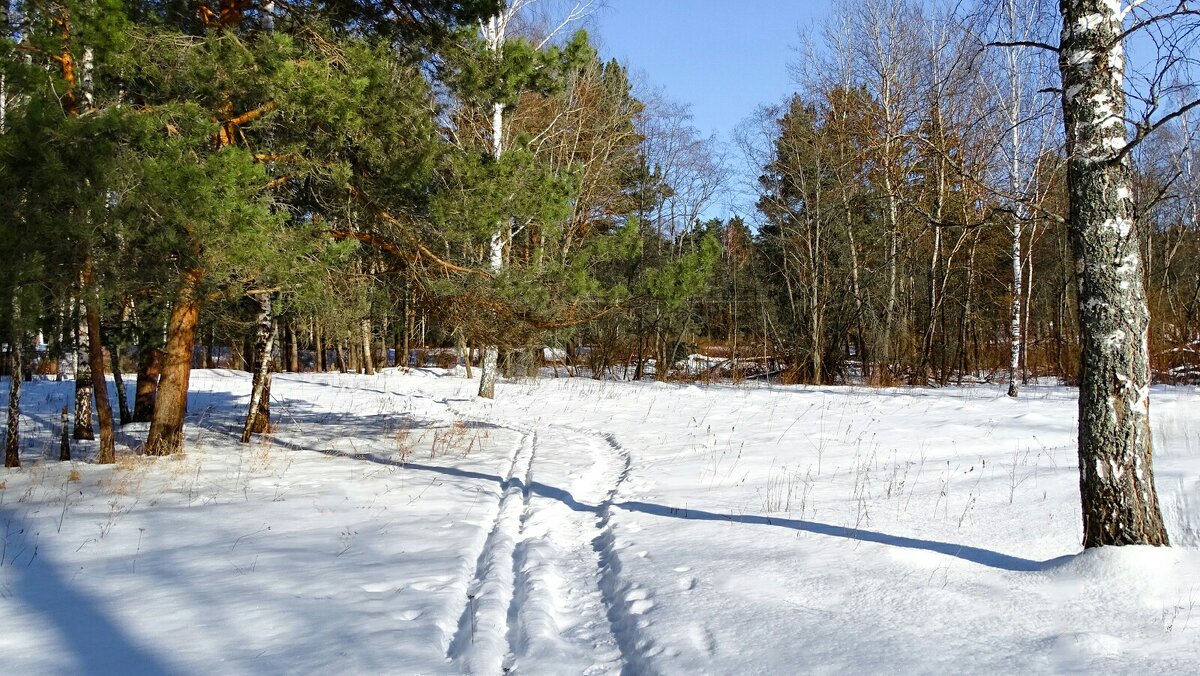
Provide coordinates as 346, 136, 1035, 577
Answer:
0, 370, 1200, 675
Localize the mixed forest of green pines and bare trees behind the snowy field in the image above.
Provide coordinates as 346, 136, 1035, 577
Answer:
0, 0, 1200, 545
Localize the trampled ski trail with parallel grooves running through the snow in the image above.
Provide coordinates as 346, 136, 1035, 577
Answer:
444, 401, 656, 675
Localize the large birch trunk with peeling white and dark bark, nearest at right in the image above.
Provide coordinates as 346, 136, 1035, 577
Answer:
1058, 0, 1168, 548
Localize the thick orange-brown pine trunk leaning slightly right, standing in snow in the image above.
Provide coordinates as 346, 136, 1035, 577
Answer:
145, 270, 202, 455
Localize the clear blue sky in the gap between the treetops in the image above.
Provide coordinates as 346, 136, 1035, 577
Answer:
592, 0, 829, 215
